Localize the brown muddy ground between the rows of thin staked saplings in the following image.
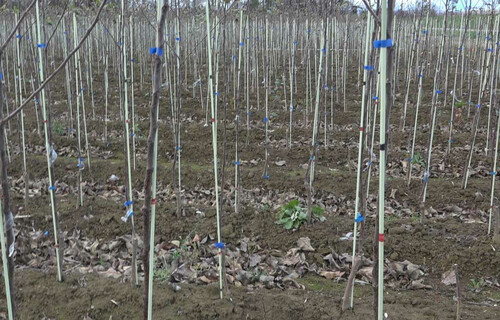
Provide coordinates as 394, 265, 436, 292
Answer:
0, 60, 500, 320
